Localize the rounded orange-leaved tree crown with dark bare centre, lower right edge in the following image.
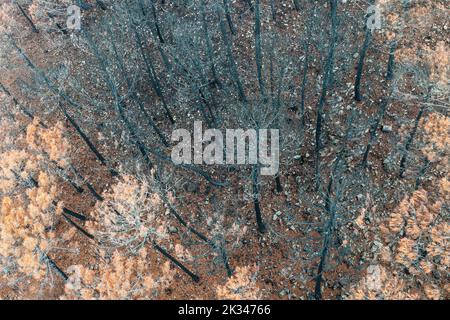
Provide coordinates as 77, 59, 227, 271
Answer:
381, 189, 450, 299
